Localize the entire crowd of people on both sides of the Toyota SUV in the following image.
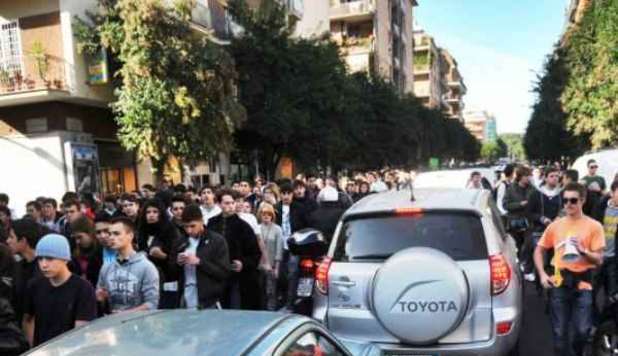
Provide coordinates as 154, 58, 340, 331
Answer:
0, 160, 618, 355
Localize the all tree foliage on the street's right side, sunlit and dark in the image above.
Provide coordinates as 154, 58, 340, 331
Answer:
524, 0, 618, 160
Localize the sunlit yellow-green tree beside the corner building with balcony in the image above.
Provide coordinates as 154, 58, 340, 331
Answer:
76, 0, 244, 175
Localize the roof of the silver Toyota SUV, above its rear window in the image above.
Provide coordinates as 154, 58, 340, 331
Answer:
344, 188, 489, 218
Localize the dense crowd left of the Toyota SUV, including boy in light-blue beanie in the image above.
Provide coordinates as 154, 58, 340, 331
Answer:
0, 172, 405, 355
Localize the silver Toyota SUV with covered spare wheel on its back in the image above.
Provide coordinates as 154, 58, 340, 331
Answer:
313, 189, 523, 356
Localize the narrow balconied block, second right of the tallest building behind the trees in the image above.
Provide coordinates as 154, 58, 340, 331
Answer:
440, 48, 468, 122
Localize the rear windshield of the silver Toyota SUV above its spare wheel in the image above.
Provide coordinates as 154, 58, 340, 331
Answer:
333, 213, 487, 261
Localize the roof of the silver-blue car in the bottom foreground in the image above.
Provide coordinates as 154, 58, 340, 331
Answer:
31, 309, 305, 356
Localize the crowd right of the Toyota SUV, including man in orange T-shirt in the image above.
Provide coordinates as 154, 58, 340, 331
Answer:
476, 160, 618, 355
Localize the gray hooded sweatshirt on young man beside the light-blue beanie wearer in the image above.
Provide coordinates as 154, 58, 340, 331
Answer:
97, 252, 159, 312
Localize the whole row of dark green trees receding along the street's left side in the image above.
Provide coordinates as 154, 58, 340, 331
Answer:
229, 0, 480, 174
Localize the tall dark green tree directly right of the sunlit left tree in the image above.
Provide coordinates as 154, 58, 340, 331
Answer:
229, 0, 348, 175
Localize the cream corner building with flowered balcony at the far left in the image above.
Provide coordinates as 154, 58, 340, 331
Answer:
0, 0, 242, 213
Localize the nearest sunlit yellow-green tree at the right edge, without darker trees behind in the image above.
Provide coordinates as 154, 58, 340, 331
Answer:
561, 0, 618, 149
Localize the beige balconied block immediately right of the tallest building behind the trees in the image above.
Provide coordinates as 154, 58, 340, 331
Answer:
413, 30, 448, 109
